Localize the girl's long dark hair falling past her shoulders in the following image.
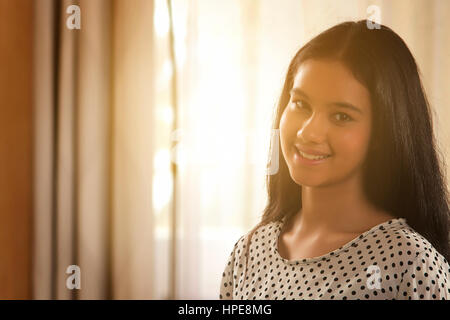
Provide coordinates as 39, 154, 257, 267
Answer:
245, 20, 450, 272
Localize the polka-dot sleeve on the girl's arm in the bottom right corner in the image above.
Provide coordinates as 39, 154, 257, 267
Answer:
396, 249, 450, 300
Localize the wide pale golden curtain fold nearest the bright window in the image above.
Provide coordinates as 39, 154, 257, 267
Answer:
111, 0, 157, 299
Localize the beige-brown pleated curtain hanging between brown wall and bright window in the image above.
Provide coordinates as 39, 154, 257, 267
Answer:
33, 0, 153, 299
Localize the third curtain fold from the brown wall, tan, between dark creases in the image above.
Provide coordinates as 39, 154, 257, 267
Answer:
77, 0, 112, 299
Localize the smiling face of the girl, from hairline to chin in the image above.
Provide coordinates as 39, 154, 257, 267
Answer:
280, 59, 372, 187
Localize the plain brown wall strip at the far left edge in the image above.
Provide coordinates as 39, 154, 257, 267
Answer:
0, 0, 32, 299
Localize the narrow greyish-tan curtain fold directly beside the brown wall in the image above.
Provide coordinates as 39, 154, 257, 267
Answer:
32, 0, 55, 299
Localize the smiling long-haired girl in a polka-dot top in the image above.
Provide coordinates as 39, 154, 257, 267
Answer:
220, 20, 450, 299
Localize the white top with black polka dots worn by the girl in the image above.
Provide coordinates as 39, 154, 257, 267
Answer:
219, 218, 450, 300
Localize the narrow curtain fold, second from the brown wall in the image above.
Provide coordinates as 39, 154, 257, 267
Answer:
53, 0, 79, 299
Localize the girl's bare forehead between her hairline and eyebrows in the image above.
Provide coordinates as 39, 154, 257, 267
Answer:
292, 59, 370, 112
